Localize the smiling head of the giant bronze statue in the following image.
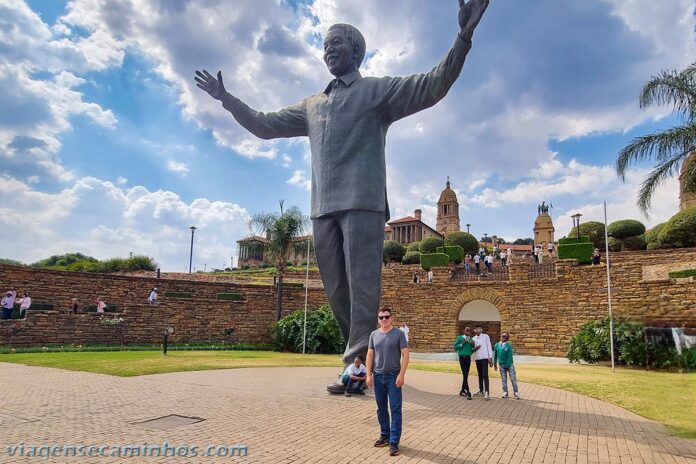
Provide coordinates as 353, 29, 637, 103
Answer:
324, 24, 365, 77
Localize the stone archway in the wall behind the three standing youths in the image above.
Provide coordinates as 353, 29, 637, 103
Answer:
456, 289, 507, 343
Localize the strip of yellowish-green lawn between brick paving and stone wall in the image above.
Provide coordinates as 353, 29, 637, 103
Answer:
0, 351, 696, 438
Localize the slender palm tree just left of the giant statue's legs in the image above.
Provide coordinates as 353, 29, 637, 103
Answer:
249, 201, 309, 320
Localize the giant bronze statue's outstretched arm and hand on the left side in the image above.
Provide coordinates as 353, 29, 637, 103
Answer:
194, 69, 307, 139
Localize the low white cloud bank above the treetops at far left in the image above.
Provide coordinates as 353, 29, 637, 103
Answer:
0, 176, 250, 271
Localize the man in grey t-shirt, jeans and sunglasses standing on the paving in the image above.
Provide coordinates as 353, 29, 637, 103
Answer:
366, 308, 408, 456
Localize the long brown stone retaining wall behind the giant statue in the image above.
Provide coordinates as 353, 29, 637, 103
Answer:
0, 248, 696, 356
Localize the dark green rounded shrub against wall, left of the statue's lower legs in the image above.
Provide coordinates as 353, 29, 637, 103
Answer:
275, 305, 345, 354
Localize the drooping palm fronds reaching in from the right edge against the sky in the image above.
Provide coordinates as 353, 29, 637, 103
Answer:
616, 63, 696, 214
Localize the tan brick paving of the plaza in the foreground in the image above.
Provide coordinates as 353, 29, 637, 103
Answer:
0, 363, 696, 464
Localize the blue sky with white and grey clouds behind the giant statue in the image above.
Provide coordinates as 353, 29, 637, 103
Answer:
0, 0, 696, 271
